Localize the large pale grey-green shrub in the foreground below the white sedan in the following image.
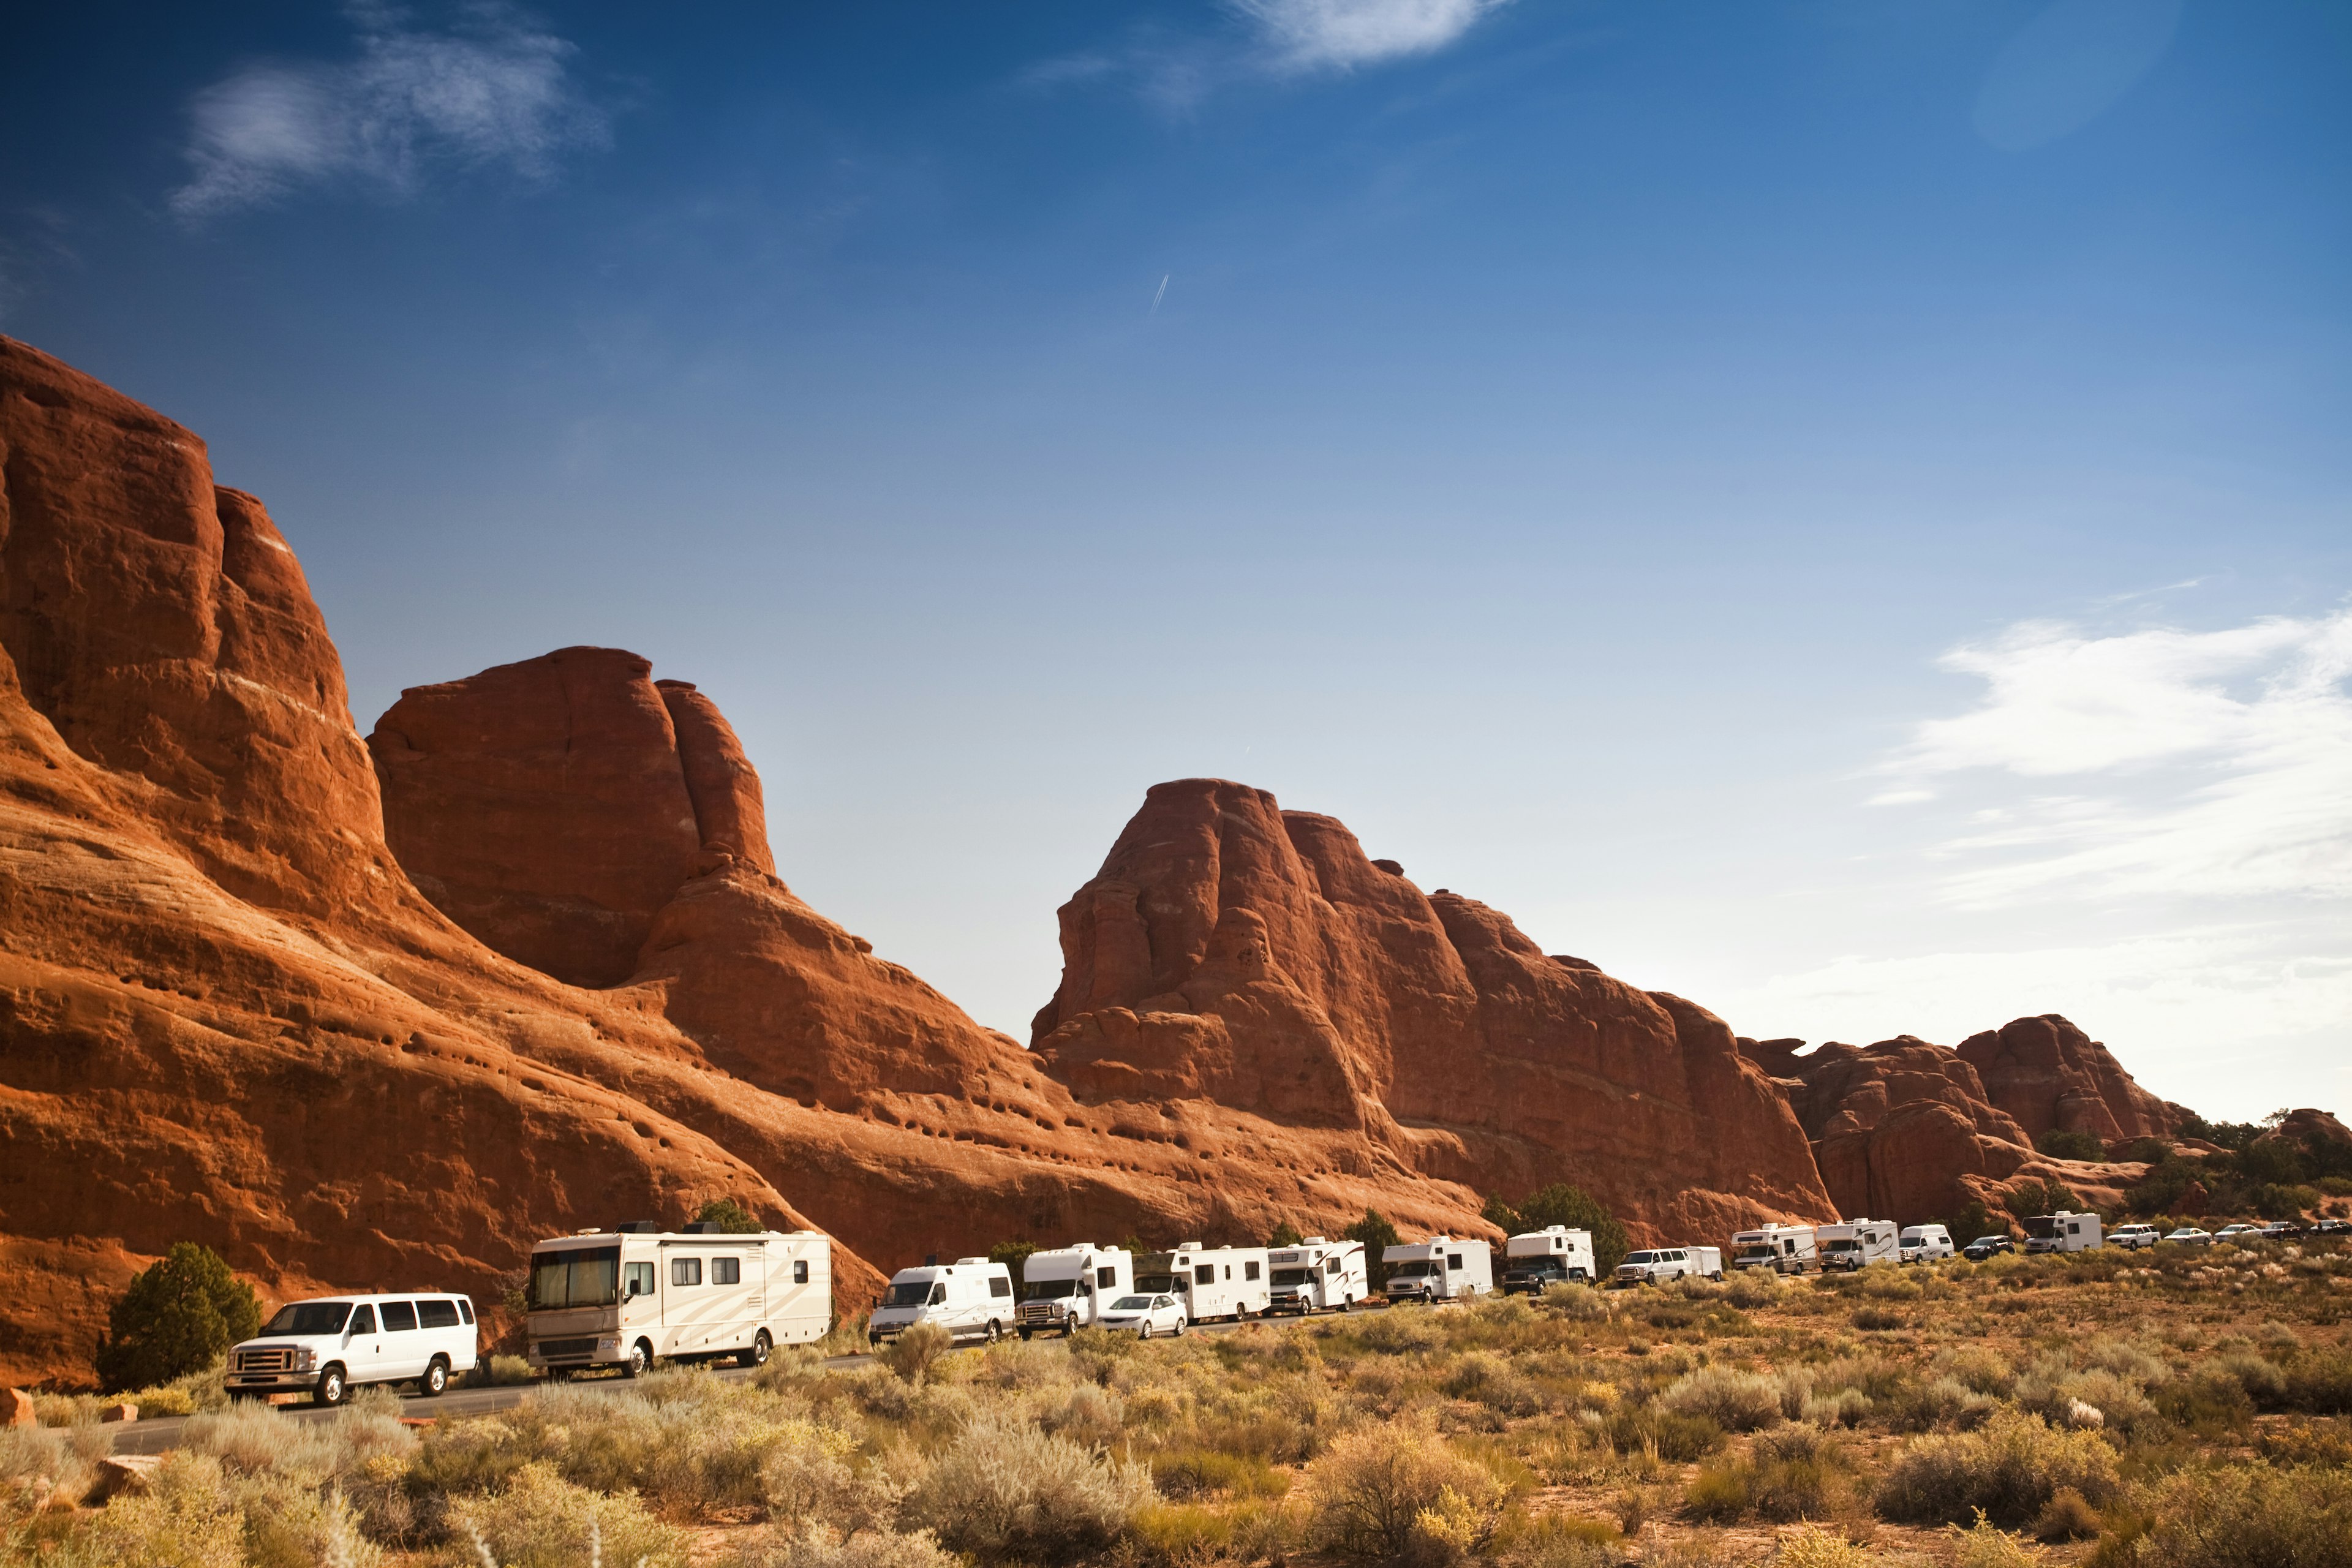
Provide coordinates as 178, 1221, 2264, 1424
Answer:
908, 1415, 1153, 1561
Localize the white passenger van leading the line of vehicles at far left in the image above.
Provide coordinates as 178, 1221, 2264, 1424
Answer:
224, 1293, 480, 1406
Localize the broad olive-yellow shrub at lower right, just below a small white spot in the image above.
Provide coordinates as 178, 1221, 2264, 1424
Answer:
1877, 1411, 2117, 1528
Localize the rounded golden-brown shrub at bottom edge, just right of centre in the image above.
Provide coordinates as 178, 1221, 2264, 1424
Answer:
1308, 1420, 1503, 1559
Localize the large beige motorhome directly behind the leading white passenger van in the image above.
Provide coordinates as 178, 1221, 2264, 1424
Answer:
524, 1220, 832, 1378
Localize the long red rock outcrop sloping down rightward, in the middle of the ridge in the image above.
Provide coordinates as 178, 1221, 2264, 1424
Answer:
1033, 778, 1830, 1237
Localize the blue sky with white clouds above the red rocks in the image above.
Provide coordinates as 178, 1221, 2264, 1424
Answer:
0, 0, 2352, 1117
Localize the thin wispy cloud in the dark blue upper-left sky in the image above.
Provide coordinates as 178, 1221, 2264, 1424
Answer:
172, 7, 605, 219
